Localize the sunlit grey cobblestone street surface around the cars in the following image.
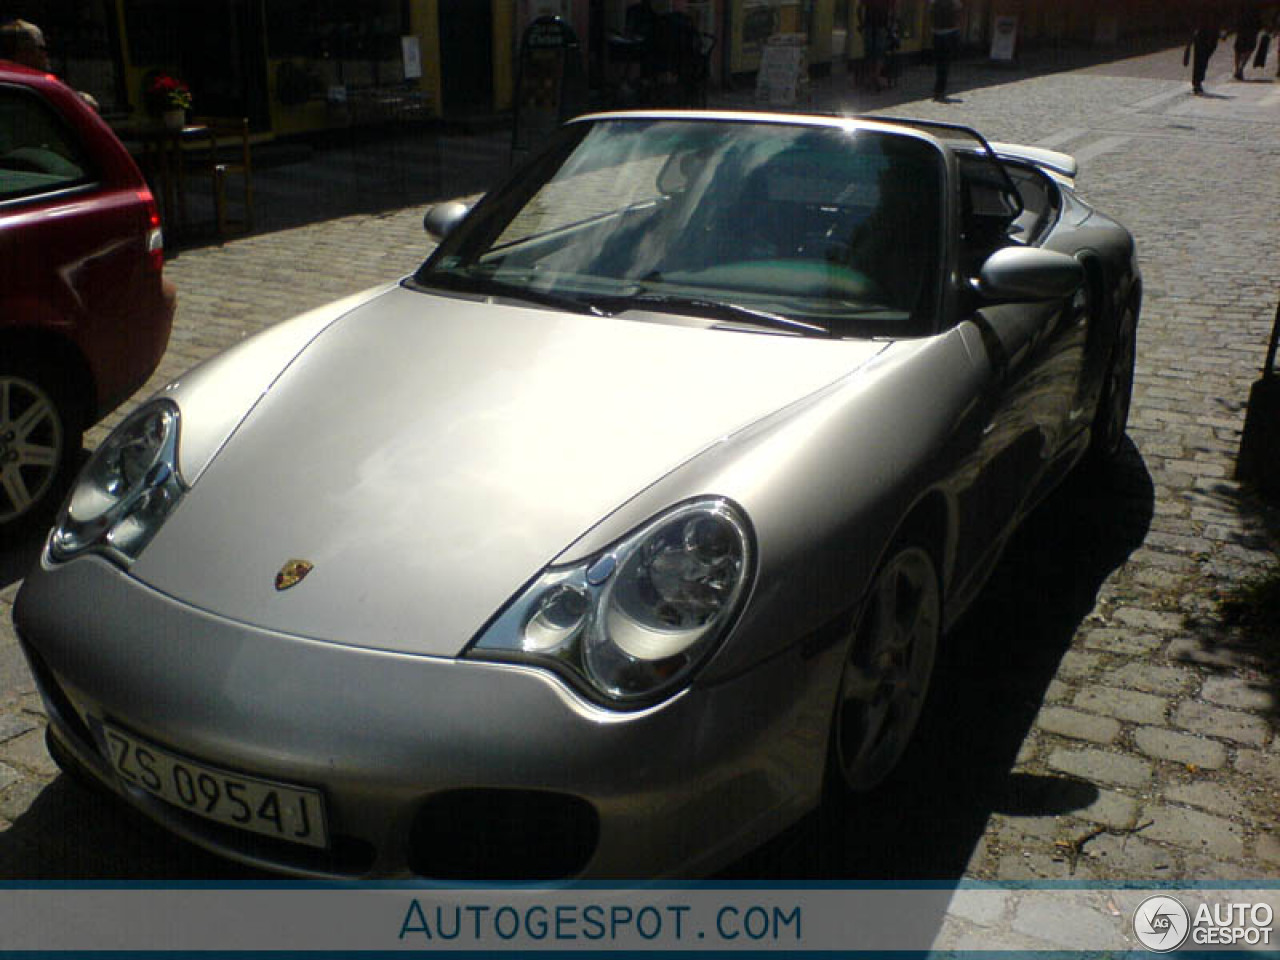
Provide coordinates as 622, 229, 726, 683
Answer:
0, 39, 1280, 948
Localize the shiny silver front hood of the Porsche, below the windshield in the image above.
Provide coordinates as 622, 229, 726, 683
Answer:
132, 288, 883, 657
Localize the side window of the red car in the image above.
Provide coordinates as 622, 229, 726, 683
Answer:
0, 87, 92, 202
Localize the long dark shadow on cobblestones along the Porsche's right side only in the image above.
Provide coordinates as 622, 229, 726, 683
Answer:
722, 444, 1155, 882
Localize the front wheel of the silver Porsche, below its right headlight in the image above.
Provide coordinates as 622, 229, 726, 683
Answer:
827, 541, 942, 795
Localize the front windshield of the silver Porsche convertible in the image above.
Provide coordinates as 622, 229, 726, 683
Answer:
416, 118, 943, 337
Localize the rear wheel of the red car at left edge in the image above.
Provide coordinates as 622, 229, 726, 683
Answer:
0, 355, 84, 535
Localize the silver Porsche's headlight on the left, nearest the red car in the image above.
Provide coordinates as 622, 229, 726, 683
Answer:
49, 399, 186, 566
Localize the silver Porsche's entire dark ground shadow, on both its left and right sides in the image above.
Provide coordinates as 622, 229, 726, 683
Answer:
0, 445, 1155, 883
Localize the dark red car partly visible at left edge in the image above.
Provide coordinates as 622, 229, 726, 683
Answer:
0, 60, 177, 535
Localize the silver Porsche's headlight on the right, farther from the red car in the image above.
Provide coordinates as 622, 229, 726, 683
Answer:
466, 499, 753, 708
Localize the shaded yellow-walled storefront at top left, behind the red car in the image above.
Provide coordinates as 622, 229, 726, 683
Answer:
6, 0, 471, 134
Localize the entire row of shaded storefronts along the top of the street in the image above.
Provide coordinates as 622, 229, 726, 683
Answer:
5, 0, 1190, 134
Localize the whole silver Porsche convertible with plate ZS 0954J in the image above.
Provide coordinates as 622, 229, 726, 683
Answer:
15, 113, 1142, 881
